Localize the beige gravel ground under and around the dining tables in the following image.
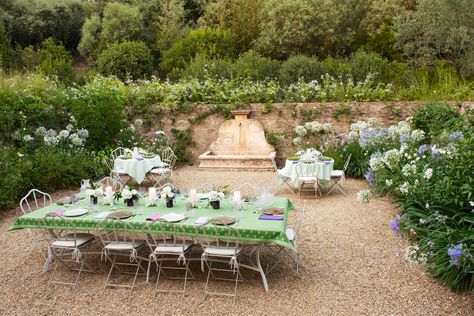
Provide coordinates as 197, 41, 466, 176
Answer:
0, 167, 474, 315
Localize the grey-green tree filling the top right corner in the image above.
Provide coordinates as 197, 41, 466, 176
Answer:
395, 0, 474, 75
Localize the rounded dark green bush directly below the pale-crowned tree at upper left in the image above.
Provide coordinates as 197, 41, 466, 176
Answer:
97, 41, 152, 80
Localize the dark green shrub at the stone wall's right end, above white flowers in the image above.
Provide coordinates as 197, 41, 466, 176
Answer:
412, 102, 465, 138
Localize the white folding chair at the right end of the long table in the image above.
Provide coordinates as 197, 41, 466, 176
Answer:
265, 201, 306, 277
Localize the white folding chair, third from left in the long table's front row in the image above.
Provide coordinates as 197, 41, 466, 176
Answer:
144, 219, 195, 297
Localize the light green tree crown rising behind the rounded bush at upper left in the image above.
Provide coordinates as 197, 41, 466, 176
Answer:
100, 2, 144, 45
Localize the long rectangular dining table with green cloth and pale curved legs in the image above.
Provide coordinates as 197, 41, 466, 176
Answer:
10, 194, 293, 291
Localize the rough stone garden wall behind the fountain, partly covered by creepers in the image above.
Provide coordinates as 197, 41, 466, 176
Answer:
145, 101, 474, 164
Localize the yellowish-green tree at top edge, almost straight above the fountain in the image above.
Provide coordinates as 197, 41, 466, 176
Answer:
199, 0, 264, 54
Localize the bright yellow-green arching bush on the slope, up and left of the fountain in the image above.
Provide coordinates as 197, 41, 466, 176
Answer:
160, 28, 232, 72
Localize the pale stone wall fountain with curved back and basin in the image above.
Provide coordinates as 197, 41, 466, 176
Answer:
199, 110, 276, 170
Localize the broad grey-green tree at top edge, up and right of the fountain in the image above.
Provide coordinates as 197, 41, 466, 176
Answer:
256, 0, 340, 59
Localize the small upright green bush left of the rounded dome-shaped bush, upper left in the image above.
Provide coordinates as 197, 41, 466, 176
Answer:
38, 37, 74, 83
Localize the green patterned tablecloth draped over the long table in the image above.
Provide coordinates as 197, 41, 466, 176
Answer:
10, 196, 293, 248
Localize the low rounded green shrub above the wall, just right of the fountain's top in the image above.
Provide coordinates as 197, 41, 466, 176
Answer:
279, 55, 323, 85
